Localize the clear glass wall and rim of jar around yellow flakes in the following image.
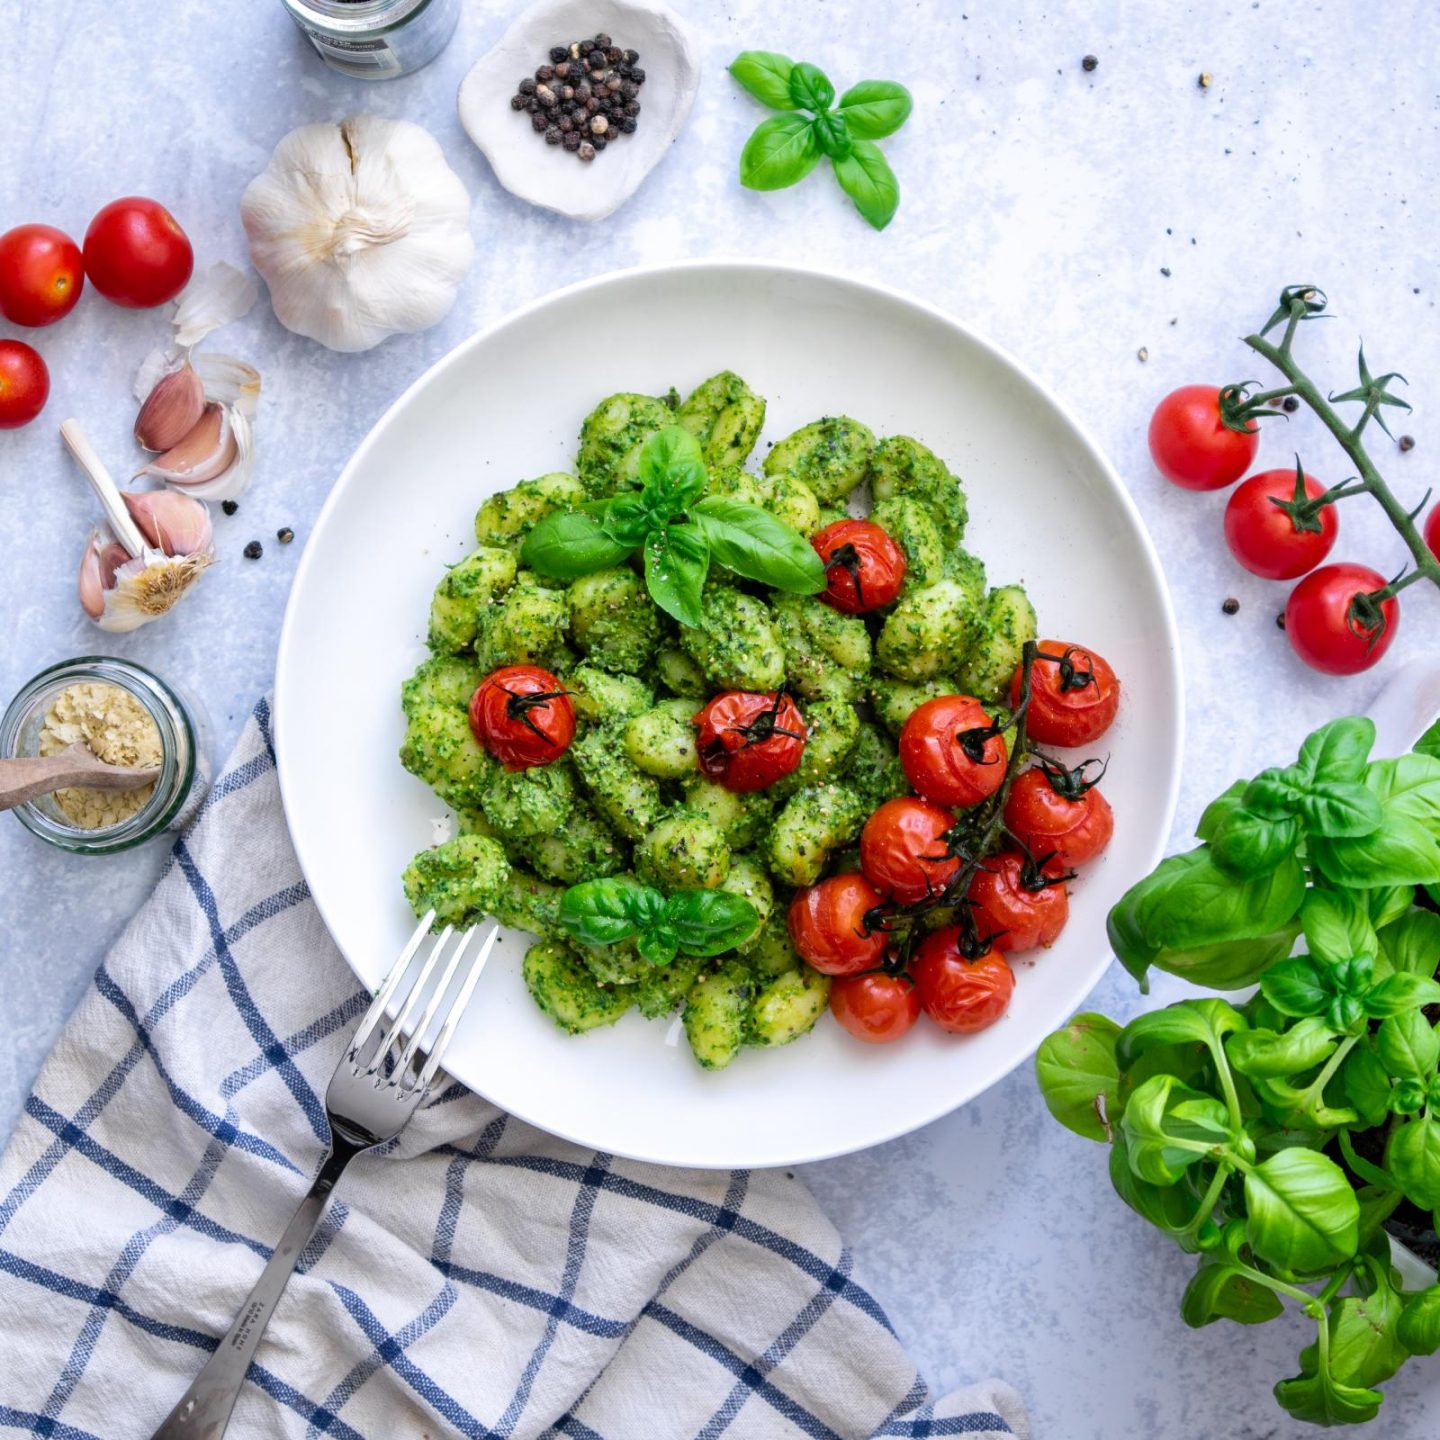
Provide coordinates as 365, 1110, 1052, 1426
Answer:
0, 655, 212, 855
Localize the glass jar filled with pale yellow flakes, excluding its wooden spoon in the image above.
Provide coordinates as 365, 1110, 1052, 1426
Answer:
0, 655, 212, 855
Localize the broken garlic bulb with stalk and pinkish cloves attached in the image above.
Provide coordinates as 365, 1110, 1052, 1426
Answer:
60, 420, 215, 631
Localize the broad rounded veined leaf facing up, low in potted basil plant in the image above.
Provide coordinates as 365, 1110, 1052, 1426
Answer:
1244, 1148, 1359, 1274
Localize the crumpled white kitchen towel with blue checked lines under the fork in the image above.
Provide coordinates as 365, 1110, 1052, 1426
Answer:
0, 703, 1027, 1440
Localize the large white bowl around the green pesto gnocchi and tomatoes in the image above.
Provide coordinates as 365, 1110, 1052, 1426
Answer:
275, 262, 1182, 1166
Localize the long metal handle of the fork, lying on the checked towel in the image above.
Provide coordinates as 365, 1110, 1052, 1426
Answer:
151, 1138, 360, 1440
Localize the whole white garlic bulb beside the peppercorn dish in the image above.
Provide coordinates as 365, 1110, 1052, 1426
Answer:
240, 115, 475, 351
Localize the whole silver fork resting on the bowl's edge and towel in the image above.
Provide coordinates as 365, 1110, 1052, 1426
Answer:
153, 910, 500, 1440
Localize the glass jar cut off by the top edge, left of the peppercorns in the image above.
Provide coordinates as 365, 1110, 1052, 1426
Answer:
282, 0, 459, 81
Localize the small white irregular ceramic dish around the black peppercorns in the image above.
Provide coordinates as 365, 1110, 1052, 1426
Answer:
456, 0, 700, 220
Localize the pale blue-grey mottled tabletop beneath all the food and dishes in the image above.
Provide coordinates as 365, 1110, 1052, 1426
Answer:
0, 0, 1440, 1440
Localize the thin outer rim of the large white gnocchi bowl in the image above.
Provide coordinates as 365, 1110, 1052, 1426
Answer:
274, 256, 1185, 1169
